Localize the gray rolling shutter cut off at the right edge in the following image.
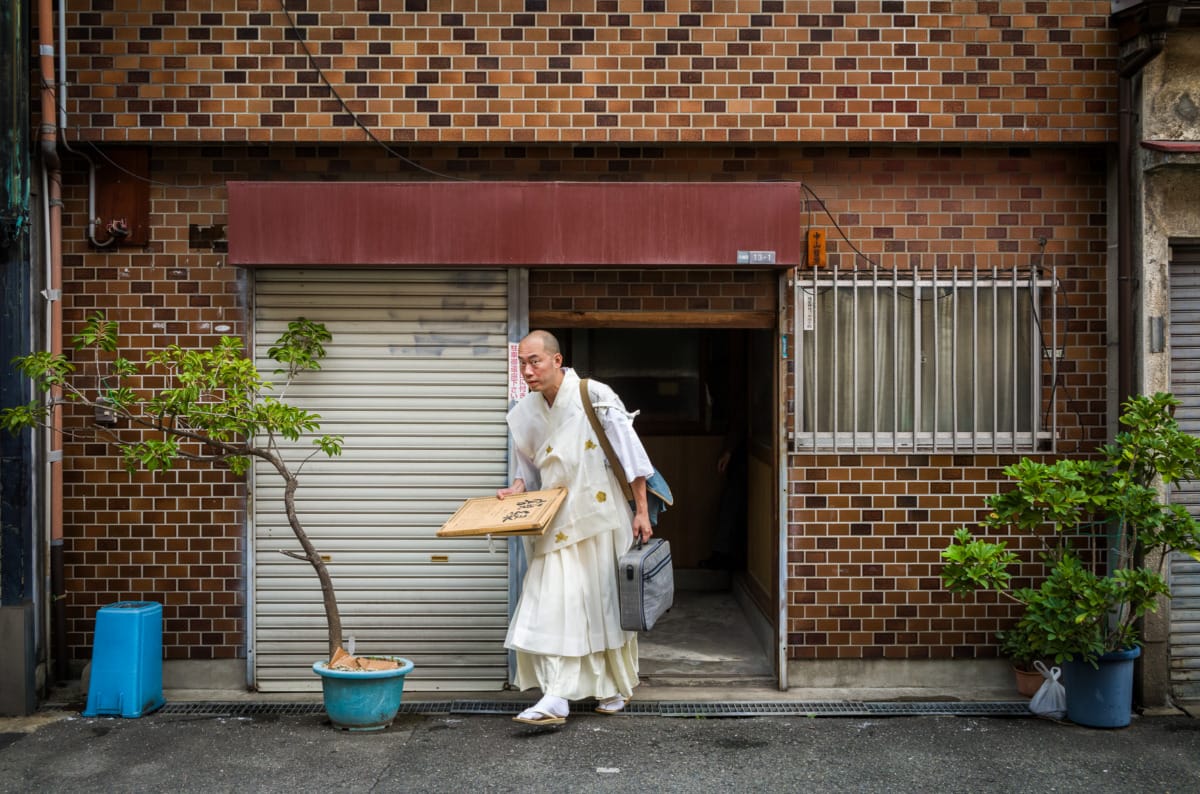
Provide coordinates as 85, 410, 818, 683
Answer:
1170, 246, 1200, 699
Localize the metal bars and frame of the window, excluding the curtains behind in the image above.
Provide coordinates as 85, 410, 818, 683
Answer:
790, 265, 1061, 453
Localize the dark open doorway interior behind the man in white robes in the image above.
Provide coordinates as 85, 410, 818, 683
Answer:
554, 329, 775, 685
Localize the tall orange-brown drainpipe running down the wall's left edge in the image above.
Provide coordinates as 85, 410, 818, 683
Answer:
37, 0, 70, 681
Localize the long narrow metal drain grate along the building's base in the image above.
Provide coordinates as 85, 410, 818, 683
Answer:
156, 700, 1030, 717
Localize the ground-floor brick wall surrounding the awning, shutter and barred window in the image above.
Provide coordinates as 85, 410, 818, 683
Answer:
56, 144, 1106, 658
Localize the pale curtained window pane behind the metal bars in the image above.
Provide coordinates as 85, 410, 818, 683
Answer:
799, 279, 1040, 443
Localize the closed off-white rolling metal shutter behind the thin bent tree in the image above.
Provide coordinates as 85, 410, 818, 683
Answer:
251, 269, 509, 692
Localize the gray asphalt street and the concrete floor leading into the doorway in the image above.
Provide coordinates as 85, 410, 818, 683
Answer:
0, 585, 1200, 794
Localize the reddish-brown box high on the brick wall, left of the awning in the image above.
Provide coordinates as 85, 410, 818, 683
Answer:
94, 146, 150, 246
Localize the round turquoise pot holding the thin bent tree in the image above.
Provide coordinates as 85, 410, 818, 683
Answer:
312, 656, 413, 730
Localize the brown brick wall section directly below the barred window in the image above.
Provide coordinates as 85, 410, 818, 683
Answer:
787, 455, 1036, 660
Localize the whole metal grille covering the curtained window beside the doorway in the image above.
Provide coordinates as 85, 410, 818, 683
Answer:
792, 266, 1060, 452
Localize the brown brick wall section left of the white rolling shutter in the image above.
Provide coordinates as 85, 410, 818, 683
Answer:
62, 194, 246, 660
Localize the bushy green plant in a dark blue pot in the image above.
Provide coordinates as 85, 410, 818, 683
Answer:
942, 393, 1200, 727
